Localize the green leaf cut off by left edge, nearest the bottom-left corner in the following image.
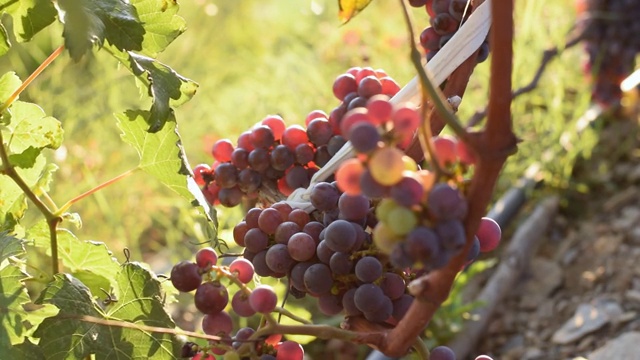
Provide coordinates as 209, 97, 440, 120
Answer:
0, 264, 57, 354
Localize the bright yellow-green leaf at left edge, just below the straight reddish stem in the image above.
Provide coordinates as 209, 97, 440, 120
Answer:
2, 101, 63, 154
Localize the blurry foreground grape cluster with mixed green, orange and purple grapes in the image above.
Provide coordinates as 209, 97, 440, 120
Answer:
335, 99, 500, 270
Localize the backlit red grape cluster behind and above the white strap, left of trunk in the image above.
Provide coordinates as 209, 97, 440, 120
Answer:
193, 67, 400, 207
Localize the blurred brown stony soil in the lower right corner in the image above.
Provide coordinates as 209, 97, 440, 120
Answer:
473, 111, 640, 360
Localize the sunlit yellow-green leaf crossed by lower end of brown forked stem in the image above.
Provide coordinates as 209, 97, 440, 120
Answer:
25, 221, 120, 295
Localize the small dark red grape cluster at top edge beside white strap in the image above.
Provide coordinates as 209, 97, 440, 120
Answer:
409, 0, 489, 63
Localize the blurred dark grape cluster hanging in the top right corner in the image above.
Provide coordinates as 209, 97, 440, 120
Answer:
576, 0, 640, 106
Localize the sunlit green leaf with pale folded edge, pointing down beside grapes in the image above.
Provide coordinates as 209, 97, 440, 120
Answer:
116, 110, 217, 231
